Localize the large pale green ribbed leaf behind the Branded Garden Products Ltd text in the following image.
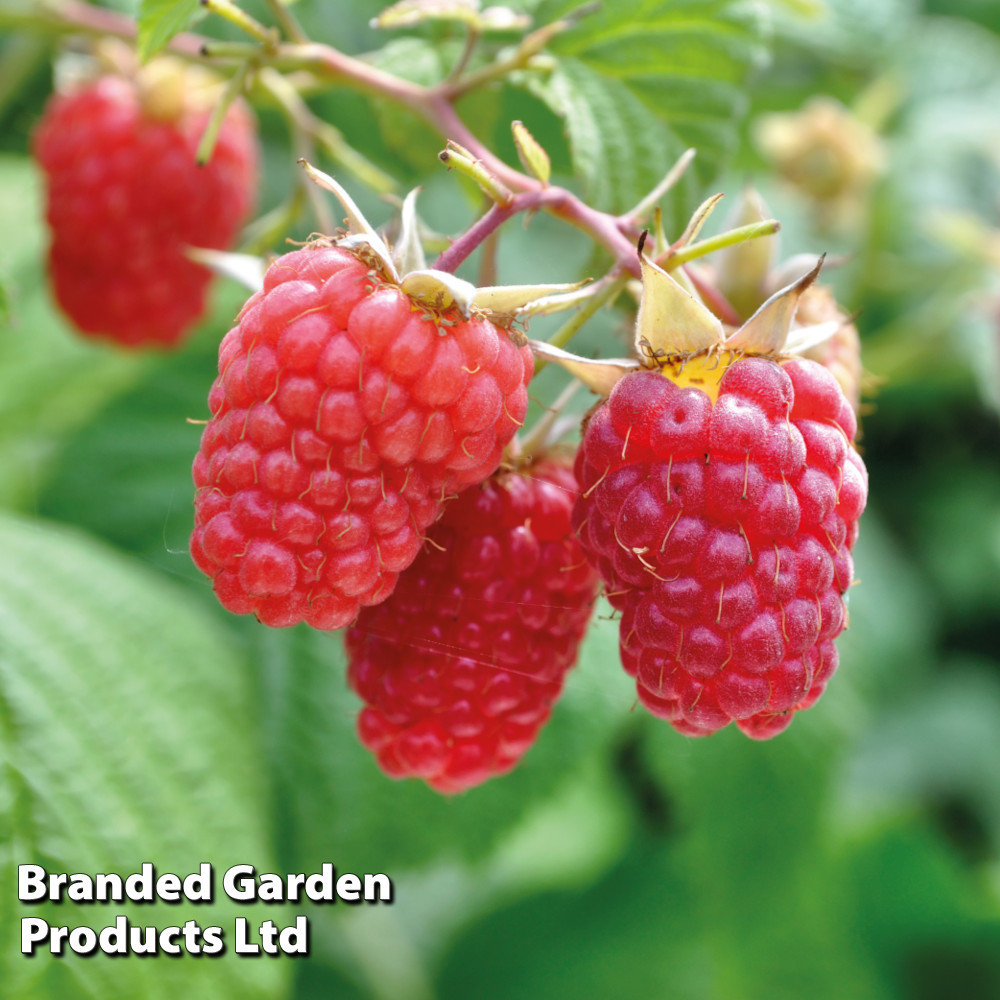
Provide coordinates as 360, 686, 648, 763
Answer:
0, 515, 287, 1000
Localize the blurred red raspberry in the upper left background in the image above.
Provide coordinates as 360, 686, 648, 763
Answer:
34, 62, 257, 346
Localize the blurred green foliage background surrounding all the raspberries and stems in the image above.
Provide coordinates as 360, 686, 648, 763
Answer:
0, 0, 1000, 1000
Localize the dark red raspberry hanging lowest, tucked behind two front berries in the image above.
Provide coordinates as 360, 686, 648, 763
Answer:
347, 461, 597, 793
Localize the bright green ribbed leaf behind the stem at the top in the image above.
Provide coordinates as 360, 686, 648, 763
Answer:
529, 0, 764, 218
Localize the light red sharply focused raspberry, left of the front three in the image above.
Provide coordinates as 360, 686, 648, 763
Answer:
191, 240, 533, 629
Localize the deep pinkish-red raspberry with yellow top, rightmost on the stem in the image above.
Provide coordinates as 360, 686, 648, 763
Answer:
574, 357, 867, 739
